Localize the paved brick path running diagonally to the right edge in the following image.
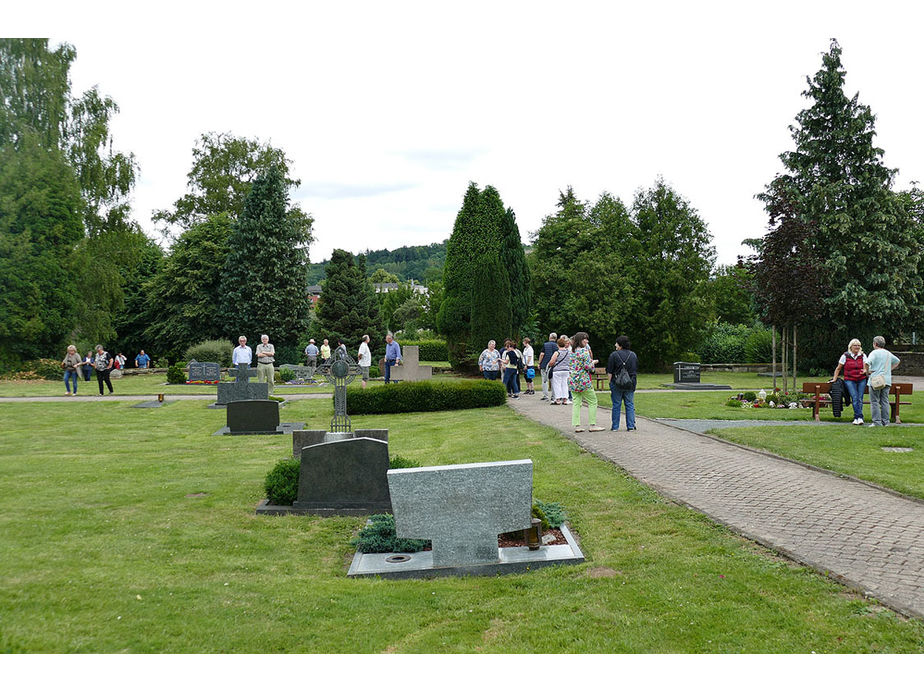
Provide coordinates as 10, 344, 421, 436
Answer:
508, 397, 924, 617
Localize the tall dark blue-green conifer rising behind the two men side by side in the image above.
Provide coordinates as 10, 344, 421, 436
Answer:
221, 168, 311, 349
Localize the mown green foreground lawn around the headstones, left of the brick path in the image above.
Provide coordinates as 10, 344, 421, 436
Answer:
0, 399, 924, 652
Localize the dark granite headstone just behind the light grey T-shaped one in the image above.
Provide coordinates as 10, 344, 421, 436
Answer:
292, 438, 391, 514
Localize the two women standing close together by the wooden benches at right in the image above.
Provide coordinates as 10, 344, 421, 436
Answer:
831, 336, 901, 428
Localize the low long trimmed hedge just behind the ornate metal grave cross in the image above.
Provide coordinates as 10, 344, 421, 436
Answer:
344, 380, 507, 414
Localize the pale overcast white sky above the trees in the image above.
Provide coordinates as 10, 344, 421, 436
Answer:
3, 0, 924, 264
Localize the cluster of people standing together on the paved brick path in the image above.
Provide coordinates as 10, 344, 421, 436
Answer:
478, 332, 638, 433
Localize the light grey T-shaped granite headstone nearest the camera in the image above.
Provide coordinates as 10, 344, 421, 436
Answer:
386, 453, 533, 567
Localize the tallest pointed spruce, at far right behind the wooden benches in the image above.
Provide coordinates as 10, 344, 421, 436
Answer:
758, 41, 924, 352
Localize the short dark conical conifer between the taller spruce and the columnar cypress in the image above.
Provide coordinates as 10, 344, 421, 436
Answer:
317, 249, 385, 353
